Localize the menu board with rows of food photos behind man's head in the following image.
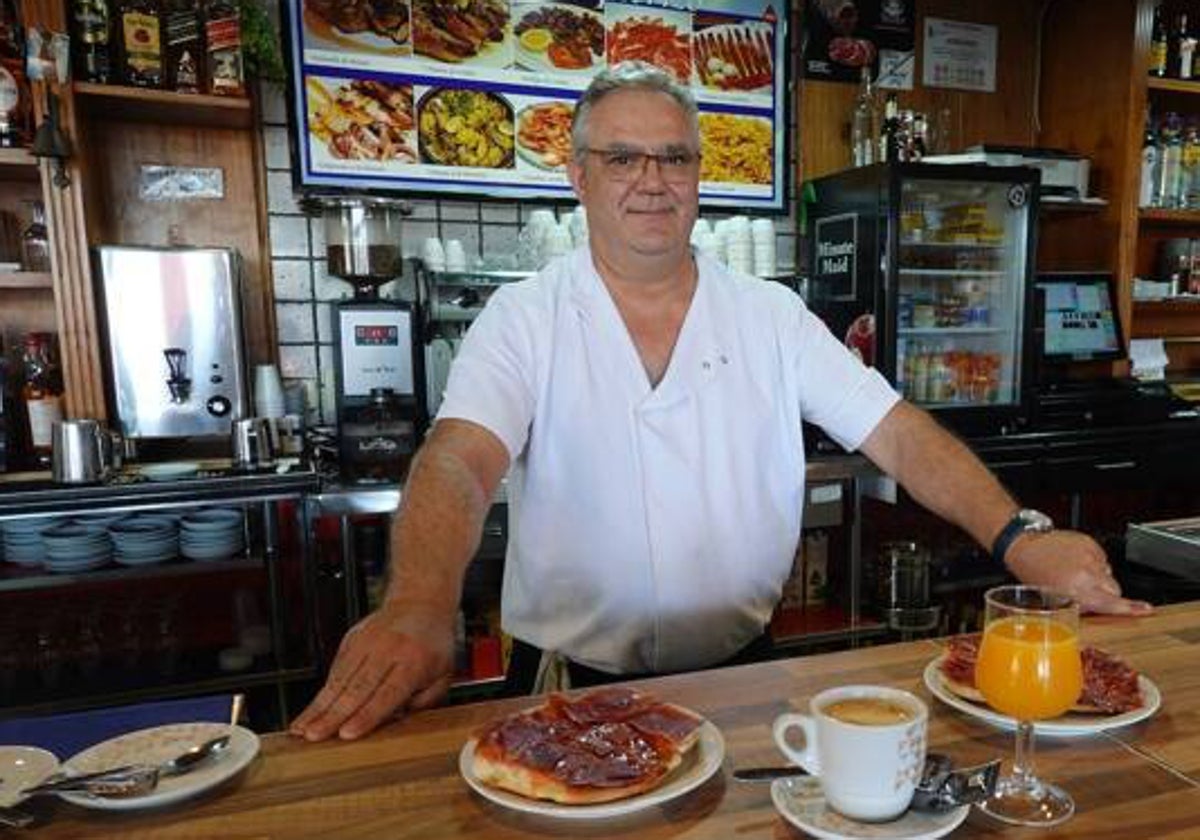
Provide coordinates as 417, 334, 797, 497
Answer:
284, 0, 788, 211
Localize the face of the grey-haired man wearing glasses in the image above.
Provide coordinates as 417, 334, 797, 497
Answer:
569, 90, 700, 264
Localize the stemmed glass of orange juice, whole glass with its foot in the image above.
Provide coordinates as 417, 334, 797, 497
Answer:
976, 586, 1084, 827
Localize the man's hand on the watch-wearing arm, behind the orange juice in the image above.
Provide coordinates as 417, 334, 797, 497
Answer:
1004, 530, 1153, 616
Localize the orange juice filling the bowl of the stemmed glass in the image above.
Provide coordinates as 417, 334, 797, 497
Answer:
976, 616, 1084, 721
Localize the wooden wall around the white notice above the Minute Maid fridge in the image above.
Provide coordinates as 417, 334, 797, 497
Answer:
797, 0, 1046, 181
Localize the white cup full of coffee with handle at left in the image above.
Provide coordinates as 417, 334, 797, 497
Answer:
773, 685, 929, 822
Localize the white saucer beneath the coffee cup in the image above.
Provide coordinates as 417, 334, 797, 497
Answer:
770, 776, 971, 840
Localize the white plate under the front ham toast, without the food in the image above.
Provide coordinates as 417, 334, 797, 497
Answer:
458, 720, 725, 820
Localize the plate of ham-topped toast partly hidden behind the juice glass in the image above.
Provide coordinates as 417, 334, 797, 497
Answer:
924, 634, 1163, 736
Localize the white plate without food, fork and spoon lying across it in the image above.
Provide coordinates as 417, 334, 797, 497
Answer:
60, 724, 258, 811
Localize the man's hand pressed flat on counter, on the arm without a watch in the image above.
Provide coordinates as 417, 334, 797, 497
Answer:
289, 602, 454, 740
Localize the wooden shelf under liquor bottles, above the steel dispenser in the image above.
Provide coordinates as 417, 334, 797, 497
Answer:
74, 82, 252, 128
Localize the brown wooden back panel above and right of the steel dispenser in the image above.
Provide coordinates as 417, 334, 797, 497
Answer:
90, 120, 276, 364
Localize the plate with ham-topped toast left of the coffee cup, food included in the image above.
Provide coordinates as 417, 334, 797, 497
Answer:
458, 686, 725, 820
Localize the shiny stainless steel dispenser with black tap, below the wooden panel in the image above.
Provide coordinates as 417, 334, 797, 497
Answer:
96, 246, 247, 438
